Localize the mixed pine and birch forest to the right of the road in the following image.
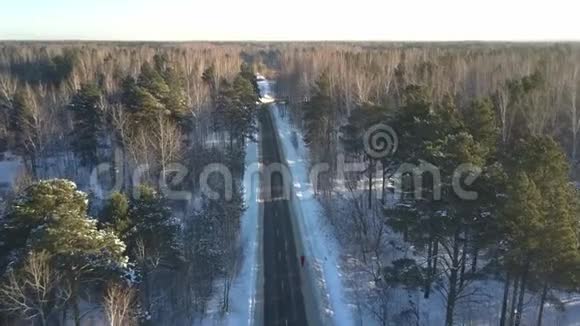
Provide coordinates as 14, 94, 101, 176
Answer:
278, 43, 580, 326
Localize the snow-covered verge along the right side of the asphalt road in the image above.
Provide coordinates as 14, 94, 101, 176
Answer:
271, 82, 354, 325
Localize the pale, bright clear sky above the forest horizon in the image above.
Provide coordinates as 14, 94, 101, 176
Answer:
0, 0, 580, 41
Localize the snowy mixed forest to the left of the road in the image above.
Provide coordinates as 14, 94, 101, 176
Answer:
0, 44, 258, 325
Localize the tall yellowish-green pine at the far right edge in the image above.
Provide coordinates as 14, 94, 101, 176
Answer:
502, 137, 579, 325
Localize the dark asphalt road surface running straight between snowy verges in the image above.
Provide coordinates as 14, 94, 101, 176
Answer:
259, 105, 307, 326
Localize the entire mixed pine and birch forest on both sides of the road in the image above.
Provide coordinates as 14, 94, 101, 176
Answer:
0, 42, 580, 326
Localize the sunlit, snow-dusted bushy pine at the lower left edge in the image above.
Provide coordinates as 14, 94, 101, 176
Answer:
0, 179, 127, 325
